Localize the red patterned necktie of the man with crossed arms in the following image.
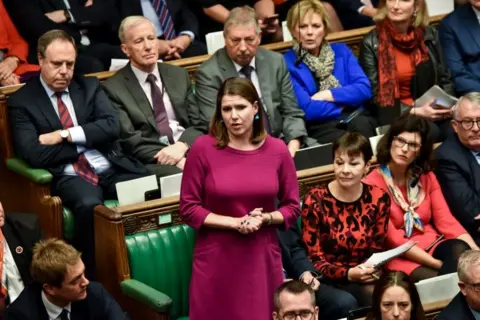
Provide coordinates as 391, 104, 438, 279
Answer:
55, 92, 98, 186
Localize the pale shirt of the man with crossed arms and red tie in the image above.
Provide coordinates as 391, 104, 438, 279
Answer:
40, 76, 110, 176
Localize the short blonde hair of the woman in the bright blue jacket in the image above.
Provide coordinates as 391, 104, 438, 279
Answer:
287, 0, 331, 35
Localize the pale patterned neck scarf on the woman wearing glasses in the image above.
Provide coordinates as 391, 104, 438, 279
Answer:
378, 165, 425, 238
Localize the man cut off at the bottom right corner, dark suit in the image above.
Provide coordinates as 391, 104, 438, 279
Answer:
437, 250, 480, 320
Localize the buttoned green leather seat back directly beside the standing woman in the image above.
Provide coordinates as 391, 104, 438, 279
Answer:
125, 225, 195, 319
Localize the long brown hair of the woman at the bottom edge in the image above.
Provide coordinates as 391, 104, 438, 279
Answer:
367, 271, 427, 320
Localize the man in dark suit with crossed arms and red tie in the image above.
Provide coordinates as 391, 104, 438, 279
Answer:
8, 30, 148, 277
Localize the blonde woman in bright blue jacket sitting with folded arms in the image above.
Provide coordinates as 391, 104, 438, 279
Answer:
285, 0, 376, 143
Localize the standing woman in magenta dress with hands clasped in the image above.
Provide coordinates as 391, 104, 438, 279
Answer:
180, 78, 300, 320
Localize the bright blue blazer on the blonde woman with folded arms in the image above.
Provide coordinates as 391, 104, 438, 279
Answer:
285, 43, 372, 121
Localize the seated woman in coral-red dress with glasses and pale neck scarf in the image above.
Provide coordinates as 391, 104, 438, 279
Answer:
364, 114, 478, 281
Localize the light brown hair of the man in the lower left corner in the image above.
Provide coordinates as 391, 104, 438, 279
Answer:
30, 238, 82, 288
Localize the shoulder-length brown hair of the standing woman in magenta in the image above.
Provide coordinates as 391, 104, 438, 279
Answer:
210, 78, 267, 148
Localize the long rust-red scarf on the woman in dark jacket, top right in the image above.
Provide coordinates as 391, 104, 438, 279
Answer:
377, 19, 428, 107
